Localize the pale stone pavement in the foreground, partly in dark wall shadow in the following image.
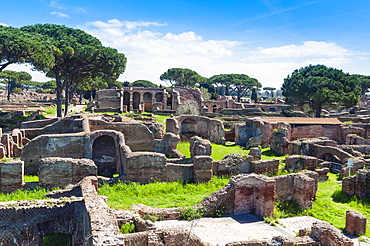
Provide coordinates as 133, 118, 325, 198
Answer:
155, 214, 370, 246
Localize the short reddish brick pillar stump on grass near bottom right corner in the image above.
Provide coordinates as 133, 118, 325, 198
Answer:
346, 209, 366, 236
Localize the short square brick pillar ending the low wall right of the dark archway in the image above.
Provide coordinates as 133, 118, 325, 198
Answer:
193, 155, 212, 183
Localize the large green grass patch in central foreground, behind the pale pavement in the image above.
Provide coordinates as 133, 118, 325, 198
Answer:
99, 176, 229, 209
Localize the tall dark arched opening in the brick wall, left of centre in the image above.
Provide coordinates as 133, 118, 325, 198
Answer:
92, 135, 119, 177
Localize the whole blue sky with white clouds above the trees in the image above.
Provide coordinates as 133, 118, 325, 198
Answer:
0, 0, 370, 88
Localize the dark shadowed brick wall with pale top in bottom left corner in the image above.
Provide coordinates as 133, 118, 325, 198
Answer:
0, 198, 92, 246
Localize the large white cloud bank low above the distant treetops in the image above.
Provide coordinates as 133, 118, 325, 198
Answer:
8, 19, 369, 88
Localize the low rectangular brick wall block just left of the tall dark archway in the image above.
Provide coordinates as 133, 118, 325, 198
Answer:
39, 157, 97, 188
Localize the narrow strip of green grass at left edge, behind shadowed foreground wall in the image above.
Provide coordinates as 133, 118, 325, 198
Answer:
0, 187, 50, 202
